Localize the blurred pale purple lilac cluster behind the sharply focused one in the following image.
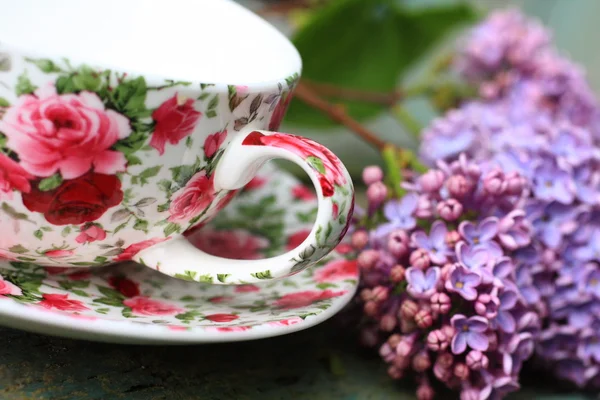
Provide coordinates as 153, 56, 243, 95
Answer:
421, 11, 600, 387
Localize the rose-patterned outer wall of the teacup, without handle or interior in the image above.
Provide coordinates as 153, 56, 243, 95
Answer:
0, 45, 304, 267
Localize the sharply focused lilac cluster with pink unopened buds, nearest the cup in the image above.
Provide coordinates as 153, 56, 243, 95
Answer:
351, 157, 540, 400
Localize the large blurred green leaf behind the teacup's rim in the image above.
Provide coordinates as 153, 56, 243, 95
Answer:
286, 0, 476, 127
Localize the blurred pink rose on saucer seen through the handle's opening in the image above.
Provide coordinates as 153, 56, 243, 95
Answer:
190, 228, 269, 260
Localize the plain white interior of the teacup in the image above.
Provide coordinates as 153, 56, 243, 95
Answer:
0, 0, 301, 85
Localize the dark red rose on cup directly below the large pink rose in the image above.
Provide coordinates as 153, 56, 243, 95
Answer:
23, 172, 123, 225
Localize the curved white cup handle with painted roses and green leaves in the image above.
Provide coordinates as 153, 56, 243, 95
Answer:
134, 130, 354, 285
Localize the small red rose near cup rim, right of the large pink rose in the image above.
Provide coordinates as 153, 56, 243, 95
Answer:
150, 94, 202, 154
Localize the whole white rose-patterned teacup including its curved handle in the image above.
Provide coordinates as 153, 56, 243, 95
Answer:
0, 0, 354, 284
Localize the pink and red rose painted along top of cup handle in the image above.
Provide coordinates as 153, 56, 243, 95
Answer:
243, 131, 347, 197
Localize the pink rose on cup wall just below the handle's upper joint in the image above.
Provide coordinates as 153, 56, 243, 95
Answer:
169, 171, 215, 223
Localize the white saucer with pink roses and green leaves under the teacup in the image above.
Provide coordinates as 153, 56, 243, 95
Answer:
0, 164, 358, 344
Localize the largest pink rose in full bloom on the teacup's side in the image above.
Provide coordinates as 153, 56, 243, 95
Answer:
0, 86, 131, 179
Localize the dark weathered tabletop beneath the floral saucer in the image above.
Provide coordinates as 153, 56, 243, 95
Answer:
0, 320, 585, 400
